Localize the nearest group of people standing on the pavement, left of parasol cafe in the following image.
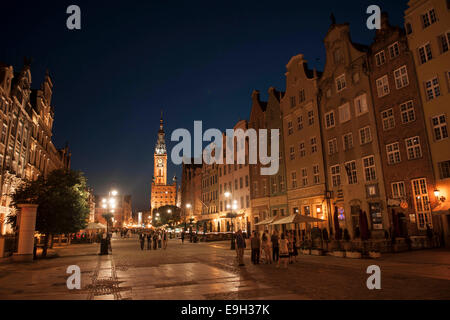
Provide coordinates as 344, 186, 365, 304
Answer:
236, 230, 298, 268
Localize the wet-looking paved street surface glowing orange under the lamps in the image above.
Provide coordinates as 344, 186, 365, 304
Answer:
0, 235, 450, 300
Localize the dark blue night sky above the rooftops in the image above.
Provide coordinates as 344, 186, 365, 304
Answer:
0, 0, 408, 210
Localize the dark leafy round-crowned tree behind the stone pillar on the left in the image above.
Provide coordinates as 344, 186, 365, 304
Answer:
8, 169, 90, 256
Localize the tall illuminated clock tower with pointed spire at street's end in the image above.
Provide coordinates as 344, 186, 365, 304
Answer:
150, 113, 177, 216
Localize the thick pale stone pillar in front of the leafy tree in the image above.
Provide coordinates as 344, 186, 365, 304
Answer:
13, 204, 38, 262
